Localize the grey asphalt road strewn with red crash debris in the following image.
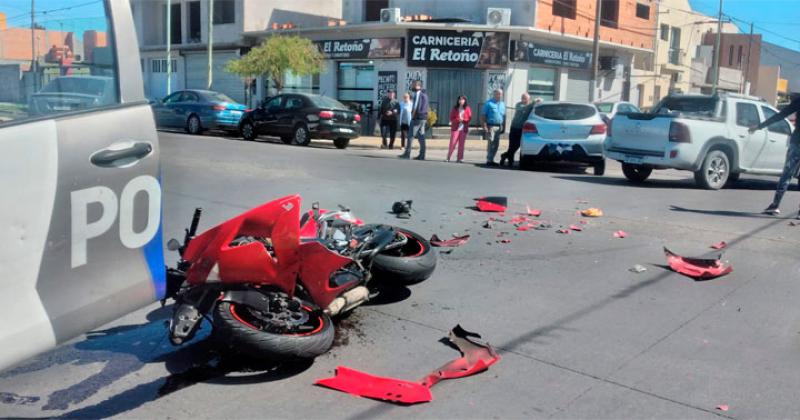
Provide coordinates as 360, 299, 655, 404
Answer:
0, 133, 800, 419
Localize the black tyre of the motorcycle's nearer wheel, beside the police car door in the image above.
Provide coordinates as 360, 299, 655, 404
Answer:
214, 302, 334, 360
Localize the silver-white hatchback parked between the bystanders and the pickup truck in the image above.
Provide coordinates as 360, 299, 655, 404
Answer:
519, 102, 607, 175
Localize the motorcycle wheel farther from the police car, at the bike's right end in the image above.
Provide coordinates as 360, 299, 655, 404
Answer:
370, 227, 436, 285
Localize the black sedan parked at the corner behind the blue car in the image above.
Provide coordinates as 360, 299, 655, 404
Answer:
239, 93, 361, 149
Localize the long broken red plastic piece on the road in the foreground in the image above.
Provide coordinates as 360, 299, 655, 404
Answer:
316, 325, 500, 404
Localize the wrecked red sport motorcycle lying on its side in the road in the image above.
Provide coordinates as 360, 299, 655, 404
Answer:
167, 195, 436, 359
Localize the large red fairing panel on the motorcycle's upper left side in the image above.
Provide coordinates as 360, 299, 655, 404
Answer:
184, 195, 300, 294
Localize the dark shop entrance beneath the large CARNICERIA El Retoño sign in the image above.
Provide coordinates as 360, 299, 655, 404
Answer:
425, 69, 486, 127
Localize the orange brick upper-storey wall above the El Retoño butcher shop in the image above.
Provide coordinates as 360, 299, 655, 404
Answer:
536, 0, 657, 49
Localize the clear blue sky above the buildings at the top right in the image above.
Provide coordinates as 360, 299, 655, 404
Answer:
689, 0, 800, 51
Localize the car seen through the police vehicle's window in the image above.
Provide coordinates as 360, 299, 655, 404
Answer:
28, 75, 117, 115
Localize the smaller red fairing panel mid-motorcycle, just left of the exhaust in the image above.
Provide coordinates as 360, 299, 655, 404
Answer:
299, 242, 353, 308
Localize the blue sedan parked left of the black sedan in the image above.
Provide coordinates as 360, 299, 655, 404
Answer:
152, 90, 248, 134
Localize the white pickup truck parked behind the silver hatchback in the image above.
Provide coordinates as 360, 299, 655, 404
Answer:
604, 93, 791, 190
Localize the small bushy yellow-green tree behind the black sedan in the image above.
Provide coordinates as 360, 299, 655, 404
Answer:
225, 36, 324, 91
